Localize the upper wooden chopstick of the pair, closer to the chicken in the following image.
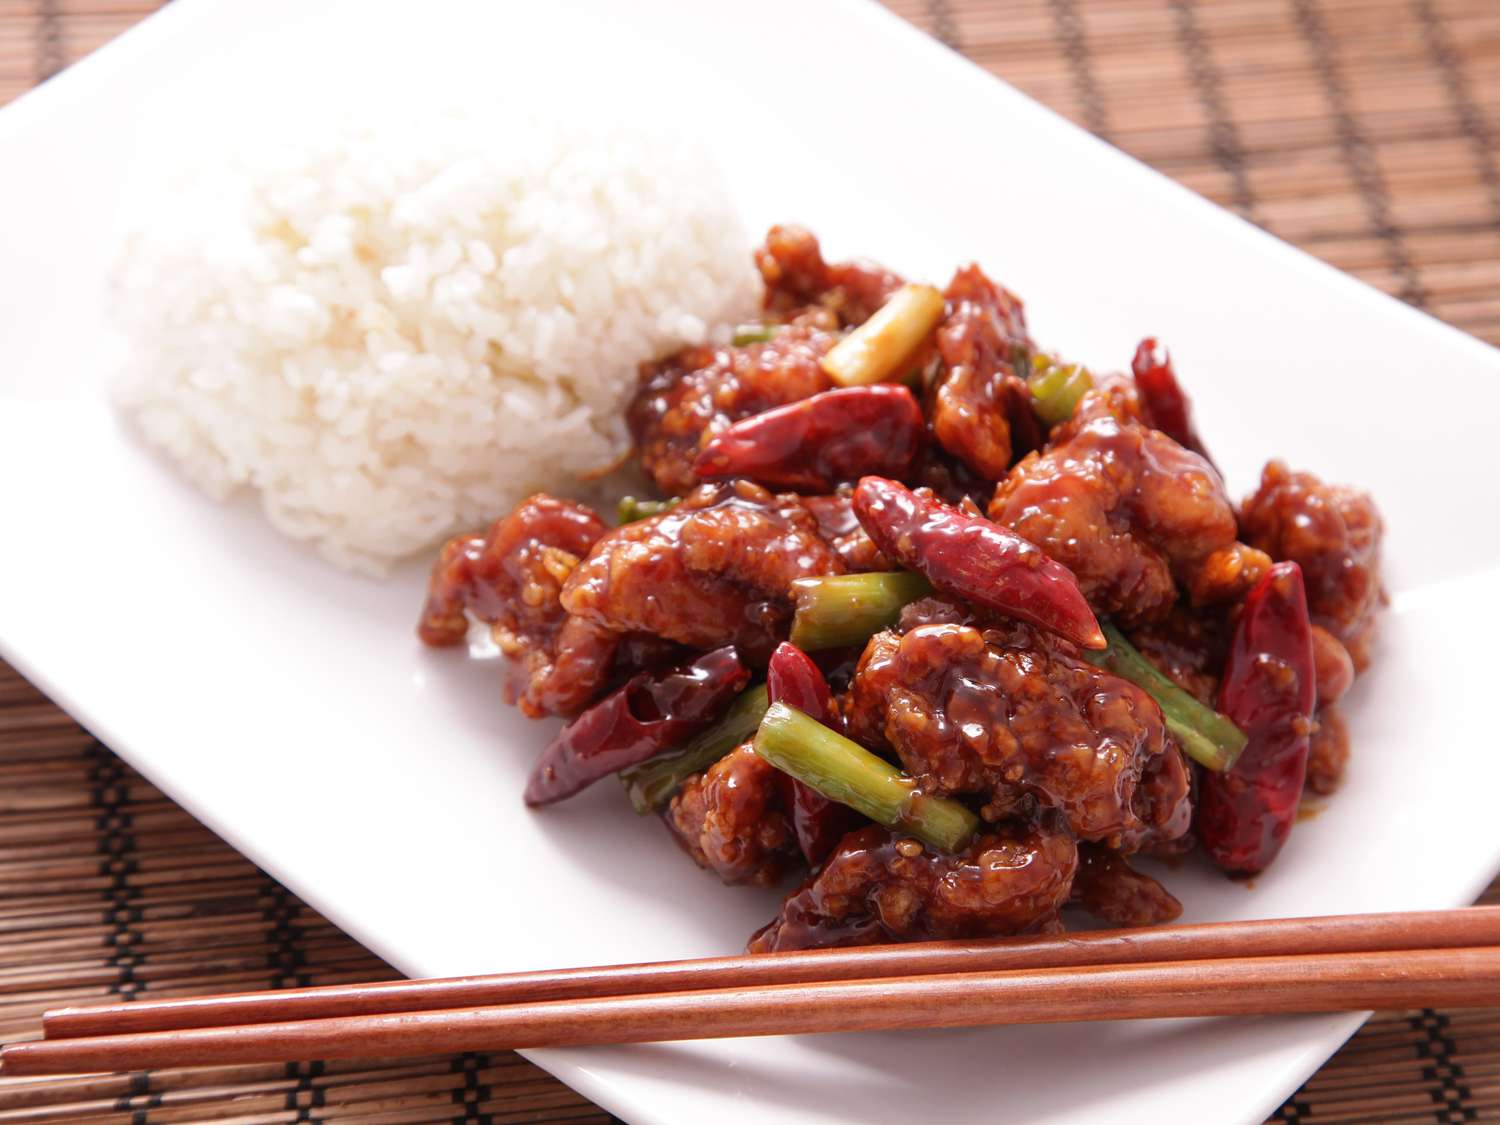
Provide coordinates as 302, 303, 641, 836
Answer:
42, 906, 1500, 1040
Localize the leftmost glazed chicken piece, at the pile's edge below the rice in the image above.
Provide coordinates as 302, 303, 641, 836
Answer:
417, 495, 620, 719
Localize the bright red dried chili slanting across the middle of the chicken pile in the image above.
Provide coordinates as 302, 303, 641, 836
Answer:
854, 477, 1107, 648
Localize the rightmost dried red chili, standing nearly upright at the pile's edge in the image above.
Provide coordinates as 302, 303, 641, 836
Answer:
1197, 563, 1317, 875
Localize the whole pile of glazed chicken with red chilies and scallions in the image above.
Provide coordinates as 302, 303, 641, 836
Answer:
419, 227, 1383, 953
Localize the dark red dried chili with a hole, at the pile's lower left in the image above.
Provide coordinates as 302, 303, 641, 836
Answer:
525, 645, 750, 806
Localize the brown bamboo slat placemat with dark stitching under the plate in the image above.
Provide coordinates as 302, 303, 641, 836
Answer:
0, 0, 1500, 1125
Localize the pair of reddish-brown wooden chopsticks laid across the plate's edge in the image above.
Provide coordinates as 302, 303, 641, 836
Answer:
0, 906, 1500, 1076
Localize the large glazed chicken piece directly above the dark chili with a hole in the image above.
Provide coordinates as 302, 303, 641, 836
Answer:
561, 480, 845, 662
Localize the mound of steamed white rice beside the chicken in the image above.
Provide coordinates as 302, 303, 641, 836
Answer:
114, 113, 758, 575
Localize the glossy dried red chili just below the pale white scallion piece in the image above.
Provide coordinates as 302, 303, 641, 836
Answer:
693, 384, 926, 492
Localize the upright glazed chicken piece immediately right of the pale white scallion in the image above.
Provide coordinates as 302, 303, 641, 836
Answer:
930, 266, 1041, 480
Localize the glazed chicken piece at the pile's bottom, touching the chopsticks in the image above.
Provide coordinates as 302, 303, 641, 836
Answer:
750, 824, 1079, 953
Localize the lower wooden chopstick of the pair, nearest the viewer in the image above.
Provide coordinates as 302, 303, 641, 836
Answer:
0, 947, 1500, 1076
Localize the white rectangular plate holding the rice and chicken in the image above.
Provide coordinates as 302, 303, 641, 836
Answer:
0, 0, 1500, 1122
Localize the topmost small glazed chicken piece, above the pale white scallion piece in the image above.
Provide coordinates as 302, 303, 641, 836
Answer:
755, 227, 903, 327
